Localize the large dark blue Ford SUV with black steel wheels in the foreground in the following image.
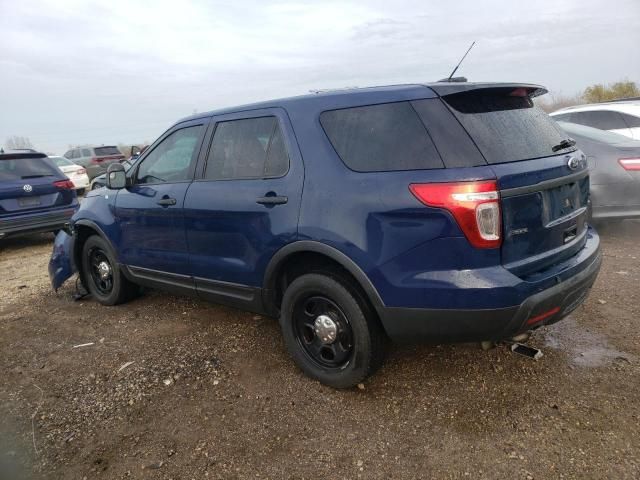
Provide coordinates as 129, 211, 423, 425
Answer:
50, 82, 601, 388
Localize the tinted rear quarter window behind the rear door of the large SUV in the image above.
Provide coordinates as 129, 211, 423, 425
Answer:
320, 102, 444, 172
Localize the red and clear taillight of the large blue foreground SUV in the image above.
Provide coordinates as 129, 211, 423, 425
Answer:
409, 181, 502, 248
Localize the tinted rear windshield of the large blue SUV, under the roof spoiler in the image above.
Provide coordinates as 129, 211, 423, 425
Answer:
443, 88, 575, 164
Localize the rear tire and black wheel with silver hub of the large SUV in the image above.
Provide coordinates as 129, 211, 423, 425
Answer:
280, 273, 385, 388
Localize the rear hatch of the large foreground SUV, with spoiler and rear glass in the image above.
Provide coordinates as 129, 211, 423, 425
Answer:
432, 84, 589, 277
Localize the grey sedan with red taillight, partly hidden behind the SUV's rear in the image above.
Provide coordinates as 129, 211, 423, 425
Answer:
558, 122, 640, 220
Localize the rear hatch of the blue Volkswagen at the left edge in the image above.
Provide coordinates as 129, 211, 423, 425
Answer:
0, 153, 75, 218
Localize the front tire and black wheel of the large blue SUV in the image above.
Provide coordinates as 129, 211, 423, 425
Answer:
82, 235, 139, 305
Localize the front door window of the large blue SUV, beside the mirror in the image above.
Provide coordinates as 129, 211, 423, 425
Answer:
137, 125, 202, 183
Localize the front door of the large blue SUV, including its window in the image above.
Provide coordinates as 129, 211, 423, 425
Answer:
115, 122, 206, 283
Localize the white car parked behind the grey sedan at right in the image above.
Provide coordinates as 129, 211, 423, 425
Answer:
550, 100, 640, 140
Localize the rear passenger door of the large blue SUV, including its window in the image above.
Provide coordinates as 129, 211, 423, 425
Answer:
185, 108, 304, 308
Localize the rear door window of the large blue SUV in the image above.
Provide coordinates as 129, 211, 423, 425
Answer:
205, 117, 289, 180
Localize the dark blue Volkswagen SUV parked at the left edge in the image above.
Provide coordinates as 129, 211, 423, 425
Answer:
0, 151, 78, 238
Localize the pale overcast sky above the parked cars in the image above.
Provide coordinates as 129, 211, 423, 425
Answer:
0, 0, 640, 153
